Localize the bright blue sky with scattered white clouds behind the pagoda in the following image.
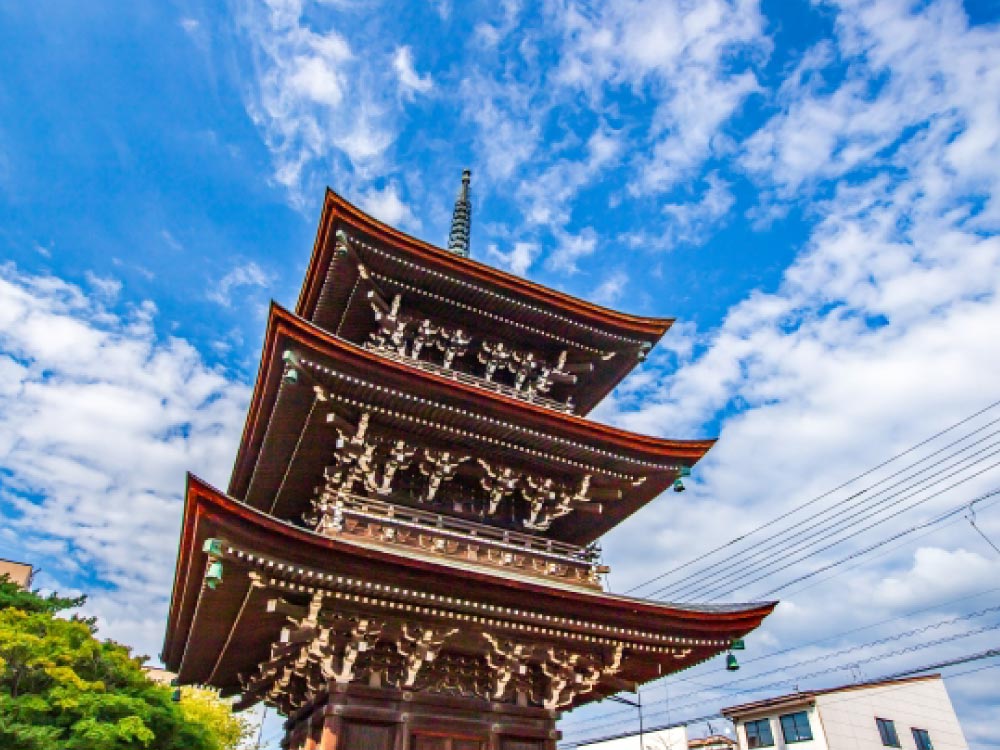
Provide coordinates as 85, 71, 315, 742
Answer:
0, 0, 1000, 746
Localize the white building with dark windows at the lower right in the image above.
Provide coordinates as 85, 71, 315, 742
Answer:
722, 674, 969, 750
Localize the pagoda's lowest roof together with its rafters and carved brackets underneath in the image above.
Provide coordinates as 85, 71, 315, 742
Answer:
164, 479, 773, 720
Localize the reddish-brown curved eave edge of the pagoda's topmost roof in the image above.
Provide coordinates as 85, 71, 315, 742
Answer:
295, 188, 674, 344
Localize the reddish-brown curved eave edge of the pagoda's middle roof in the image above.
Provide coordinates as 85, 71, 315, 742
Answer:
229, 302, 716, 497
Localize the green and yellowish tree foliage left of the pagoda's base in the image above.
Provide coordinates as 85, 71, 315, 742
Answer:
0, 577, 245, 750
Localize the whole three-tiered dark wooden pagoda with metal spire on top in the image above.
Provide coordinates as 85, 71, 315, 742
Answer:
162, 172, 774, 750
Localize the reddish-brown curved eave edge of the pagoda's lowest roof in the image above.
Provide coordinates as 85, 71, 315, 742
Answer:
162, 475, 776, 670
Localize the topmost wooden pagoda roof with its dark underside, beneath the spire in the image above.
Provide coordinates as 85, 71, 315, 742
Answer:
295, 189, 673, 414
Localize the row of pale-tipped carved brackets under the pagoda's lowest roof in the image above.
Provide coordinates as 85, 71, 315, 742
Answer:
241, 592, 625, 712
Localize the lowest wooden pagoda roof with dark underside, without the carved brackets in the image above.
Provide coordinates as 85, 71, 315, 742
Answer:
161, 476, 775, 700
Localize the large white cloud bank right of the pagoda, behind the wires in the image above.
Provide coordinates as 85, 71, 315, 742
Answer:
568, 2, 1000, 745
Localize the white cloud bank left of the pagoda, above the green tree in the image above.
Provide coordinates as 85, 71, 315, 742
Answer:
0, 265, 248, 654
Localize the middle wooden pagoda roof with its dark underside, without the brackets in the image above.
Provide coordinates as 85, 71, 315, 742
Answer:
229, 305, 714, 545
